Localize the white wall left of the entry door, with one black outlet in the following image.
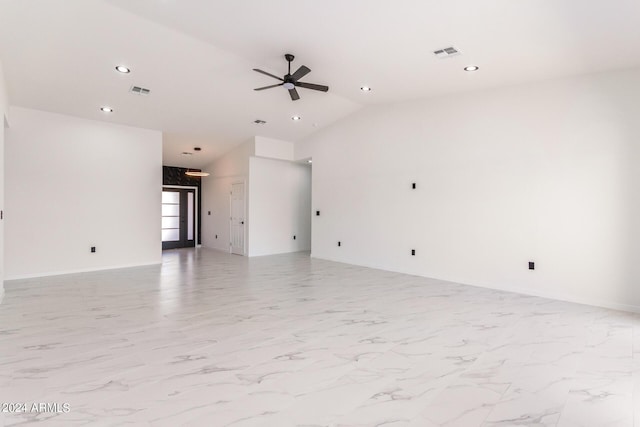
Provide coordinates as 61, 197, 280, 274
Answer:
5, 108, 162, 279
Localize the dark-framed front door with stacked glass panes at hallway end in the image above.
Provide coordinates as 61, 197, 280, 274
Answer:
162, 187, 197, 250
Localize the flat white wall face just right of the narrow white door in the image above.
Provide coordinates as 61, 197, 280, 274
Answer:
249, 157, 311, 256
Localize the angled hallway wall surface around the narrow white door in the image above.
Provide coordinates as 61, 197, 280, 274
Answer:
202, 139, 255, 252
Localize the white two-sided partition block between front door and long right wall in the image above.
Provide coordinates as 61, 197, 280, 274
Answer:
202, 137, 311, 256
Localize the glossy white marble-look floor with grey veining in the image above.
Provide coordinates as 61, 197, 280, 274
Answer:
0, 249, 640, 427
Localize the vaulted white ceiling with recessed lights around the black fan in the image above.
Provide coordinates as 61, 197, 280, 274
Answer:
0, 0, 640, 166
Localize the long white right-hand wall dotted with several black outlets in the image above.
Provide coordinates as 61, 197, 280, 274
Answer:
296, 70, 640, 310
